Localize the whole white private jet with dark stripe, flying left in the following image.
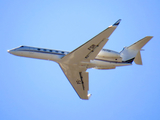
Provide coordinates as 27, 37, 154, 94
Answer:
8, 19, 153, 100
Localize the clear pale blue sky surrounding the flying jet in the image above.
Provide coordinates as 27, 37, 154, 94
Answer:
0, 0, 160, 120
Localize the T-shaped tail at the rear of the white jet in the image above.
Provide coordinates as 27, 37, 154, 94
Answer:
120, 36, 153, 65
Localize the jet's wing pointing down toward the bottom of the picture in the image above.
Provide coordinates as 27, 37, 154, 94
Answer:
59, 63, 91, 100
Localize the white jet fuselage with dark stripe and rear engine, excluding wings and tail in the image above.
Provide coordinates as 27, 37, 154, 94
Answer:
8, 46, 131, 69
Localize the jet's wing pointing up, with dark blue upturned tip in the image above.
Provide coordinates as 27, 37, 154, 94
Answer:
62, 19, 121, 64
